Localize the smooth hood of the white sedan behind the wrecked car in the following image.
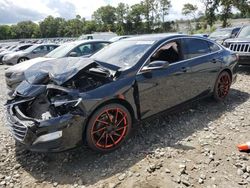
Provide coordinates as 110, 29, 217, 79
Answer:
6, 57, 53, 73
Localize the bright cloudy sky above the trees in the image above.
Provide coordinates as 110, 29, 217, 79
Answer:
0, 0, 202, 24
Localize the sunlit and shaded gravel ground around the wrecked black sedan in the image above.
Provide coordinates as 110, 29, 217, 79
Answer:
0, 66, 250, 188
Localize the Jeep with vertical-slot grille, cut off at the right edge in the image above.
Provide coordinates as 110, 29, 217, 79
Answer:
223, 25, 250, 65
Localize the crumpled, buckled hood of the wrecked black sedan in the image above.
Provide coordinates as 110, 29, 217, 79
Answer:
24, 57, 97, 85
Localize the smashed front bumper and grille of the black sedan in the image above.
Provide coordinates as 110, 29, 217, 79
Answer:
6, 105, 85, 152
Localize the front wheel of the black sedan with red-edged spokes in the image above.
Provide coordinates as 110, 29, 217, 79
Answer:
86, 104, 132, 153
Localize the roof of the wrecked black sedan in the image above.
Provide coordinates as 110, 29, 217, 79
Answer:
124, 33, 188, 41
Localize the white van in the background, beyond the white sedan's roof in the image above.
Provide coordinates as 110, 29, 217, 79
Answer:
78, 32, 117, 40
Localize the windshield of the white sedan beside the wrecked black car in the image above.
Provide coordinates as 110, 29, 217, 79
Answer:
45, 43, 76, 58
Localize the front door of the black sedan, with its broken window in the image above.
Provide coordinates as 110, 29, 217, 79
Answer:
136, 40, 190, 119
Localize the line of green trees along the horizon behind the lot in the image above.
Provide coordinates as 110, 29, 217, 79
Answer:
0, 0, 250, 39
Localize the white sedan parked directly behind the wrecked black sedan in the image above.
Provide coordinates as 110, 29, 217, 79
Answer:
5, 40, 110, 91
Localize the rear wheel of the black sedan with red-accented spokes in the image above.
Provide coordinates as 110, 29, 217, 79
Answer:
213, 71, 232, 102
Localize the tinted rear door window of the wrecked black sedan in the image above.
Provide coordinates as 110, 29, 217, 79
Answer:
182, 39, 210, 59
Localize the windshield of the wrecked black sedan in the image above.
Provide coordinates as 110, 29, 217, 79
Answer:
91, 40, 154, 69
